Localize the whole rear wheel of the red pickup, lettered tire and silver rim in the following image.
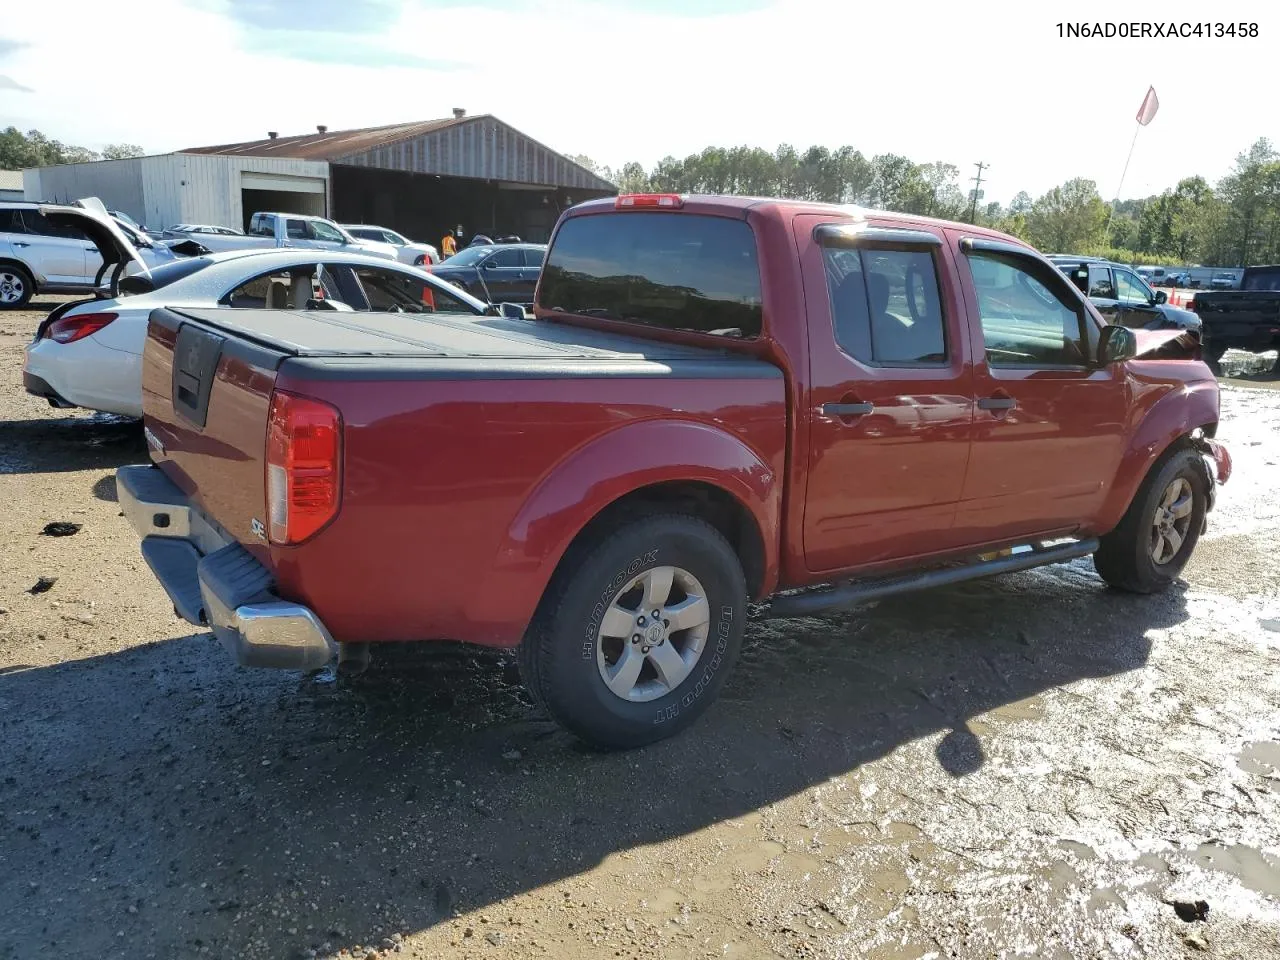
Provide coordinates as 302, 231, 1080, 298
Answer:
520, 513, 746, 748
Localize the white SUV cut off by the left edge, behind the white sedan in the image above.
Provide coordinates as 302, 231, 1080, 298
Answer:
0, 197, 189, 310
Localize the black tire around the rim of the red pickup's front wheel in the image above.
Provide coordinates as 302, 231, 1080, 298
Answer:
1093, 447, 1211, 594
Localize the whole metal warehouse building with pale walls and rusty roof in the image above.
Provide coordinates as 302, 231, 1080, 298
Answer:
23, 110, 618, 243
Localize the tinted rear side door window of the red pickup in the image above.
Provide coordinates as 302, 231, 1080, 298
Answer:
823, 247, 947, 365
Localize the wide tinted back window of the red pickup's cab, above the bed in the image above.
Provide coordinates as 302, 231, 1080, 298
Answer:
539, 212, 762, 337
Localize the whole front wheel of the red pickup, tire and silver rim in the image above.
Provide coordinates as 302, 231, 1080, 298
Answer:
1093, 448, 1212, 594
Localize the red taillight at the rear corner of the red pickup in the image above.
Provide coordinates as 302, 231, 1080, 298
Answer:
266, 390, 342, 544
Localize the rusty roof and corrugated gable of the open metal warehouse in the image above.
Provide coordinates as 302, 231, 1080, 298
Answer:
179, 114, 617, 193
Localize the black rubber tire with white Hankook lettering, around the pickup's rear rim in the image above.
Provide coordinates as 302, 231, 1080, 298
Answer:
518, 513, 746, 749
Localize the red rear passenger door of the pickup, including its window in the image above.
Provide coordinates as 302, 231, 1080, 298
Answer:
795, 216, 973, 573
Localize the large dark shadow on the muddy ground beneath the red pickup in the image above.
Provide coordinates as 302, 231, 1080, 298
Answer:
0, 561, 1188, 957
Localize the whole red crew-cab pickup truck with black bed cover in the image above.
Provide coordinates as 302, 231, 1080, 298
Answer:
118, 195, 1230, 746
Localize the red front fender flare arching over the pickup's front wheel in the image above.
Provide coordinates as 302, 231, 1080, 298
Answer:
1098, 380, 1219, 534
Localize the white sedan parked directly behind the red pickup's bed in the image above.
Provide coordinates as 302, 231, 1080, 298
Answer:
30, 250, 494, 417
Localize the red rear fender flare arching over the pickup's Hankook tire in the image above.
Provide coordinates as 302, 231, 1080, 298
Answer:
468, 420, 782, 645
